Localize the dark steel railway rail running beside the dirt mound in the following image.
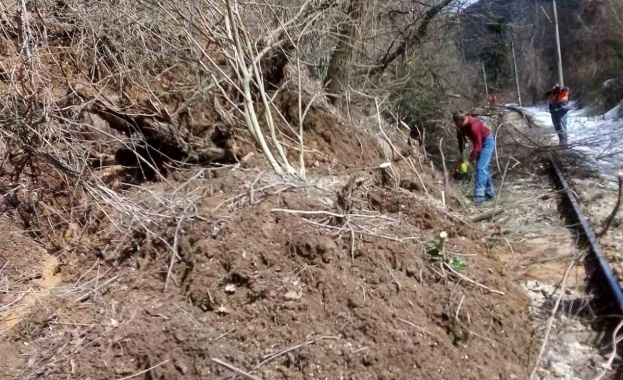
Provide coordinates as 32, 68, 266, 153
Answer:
549, 154, 623, 315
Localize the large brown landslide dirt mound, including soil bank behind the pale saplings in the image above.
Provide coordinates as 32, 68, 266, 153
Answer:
0, 84, 532, 379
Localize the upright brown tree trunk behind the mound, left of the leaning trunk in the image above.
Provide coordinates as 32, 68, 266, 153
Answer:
325, 0, 368, 104
